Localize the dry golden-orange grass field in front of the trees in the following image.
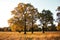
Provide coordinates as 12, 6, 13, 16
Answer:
0, 31, 60, 40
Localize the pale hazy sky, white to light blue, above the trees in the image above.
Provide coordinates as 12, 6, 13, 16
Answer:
0, 0, 60, 27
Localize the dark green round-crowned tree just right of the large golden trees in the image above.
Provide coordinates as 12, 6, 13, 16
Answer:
38, 10, 54, 32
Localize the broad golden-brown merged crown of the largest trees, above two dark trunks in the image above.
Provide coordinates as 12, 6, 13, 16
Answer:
8, 3, 39, 31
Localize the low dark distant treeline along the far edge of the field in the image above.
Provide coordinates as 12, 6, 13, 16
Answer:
0, 26, 58, 32
